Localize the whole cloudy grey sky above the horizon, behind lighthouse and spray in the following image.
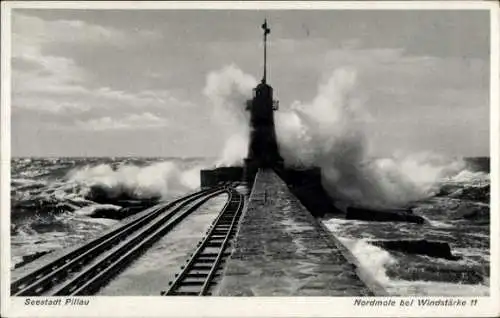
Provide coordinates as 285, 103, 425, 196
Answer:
11, 9, 490, 156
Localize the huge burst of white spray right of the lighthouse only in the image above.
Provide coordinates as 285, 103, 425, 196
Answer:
276, 68, 465, 206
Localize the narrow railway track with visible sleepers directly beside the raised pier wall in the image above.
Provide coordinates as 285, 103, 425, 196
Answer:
161, 191, 244, 296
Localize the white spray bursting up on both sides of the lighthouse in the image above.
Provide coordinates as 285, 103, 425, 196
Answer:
204, 65, 476, 207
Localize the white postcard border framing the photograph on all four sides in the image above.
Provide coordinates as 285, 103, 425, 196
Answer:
0, 1, 500, 317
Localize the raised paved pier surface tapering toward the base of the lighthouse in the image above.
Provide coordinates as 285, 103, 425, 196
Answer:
214, 170, 373, 296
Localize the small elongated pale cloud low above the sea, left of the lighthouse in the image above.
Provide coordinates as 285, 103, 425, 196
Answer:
76, 112, 167, 131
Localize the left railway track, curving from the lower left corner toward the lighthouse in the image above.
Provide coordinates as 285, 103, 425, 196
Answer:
11, 187, 232, 296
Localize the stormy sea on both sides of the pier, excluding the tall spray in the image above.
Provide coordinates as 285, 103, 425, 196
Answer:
10, 157, 490, 296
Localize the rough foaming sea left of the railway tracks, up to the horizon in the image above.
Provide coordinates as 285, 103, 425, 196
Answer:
10, 158, 209, 267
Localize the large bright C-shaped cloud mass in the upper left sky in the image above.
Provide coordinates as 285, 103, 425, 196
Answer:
12, 14, 177, 114
